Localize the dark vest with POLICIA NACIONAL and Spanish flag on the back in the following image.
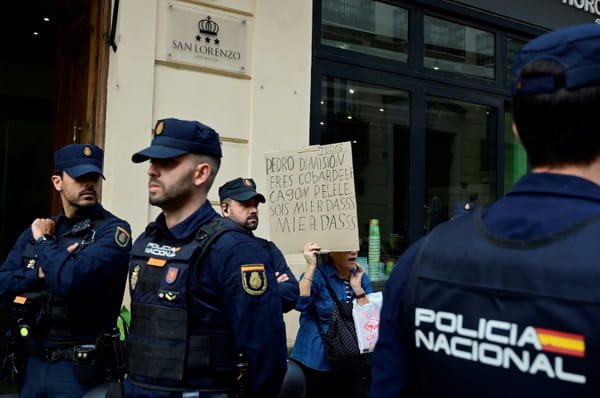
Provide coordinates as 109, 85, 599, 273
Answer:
404, 208, 600, 397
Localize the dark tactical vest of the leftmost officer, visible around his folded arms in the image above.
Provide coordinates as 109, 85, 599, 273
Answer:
18, 217, 111, 344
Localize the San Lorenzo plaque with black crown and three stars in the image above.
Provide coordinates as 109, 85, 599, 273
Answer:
157, 2, 250, 74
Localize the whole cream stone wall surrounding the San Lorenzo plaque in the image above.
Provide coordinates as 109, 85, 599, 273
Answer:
103, 0, 312, 343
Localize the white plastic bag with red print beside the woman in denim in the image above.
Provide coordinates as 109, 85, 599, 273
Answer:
352, 292, 383, 353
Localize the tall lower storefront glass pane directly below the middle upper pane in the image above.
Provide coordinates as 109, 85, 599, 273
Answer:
425, 96, 496, 232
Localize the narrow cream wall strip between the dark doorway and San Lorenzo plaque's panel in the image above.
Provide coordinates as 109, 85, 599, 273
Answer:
103, 0, 156, 236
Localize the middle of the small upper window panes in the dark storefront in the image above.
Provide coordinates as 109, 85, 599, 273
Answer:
424, 15, 496, 79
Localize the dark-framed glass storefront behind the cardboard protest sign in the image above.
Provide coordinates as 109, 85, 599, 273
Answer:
310, 0, 541, 280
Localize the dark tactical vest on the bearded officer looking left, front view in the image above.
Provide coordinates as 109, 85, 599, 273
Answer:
127, 218, 244, 391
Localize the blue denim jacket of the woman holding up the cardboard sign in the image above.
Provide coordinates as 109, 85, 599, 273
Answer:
291, 263, 373, 371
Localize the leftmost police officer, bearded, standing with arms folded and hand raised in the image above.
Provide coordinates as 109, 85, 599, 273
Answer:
0, 144, 131, 397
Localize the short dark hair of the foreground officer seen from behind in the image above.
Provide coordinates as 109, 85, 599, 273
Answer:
513, 60, 600, 167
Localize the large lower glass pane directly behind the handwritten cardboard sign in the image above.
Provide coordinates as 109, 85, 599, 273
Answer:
321, 76, 409, 272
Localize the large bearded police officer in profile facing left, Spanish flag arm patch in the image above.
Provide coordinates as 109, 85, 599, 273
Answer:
124, 119, 287, 398
